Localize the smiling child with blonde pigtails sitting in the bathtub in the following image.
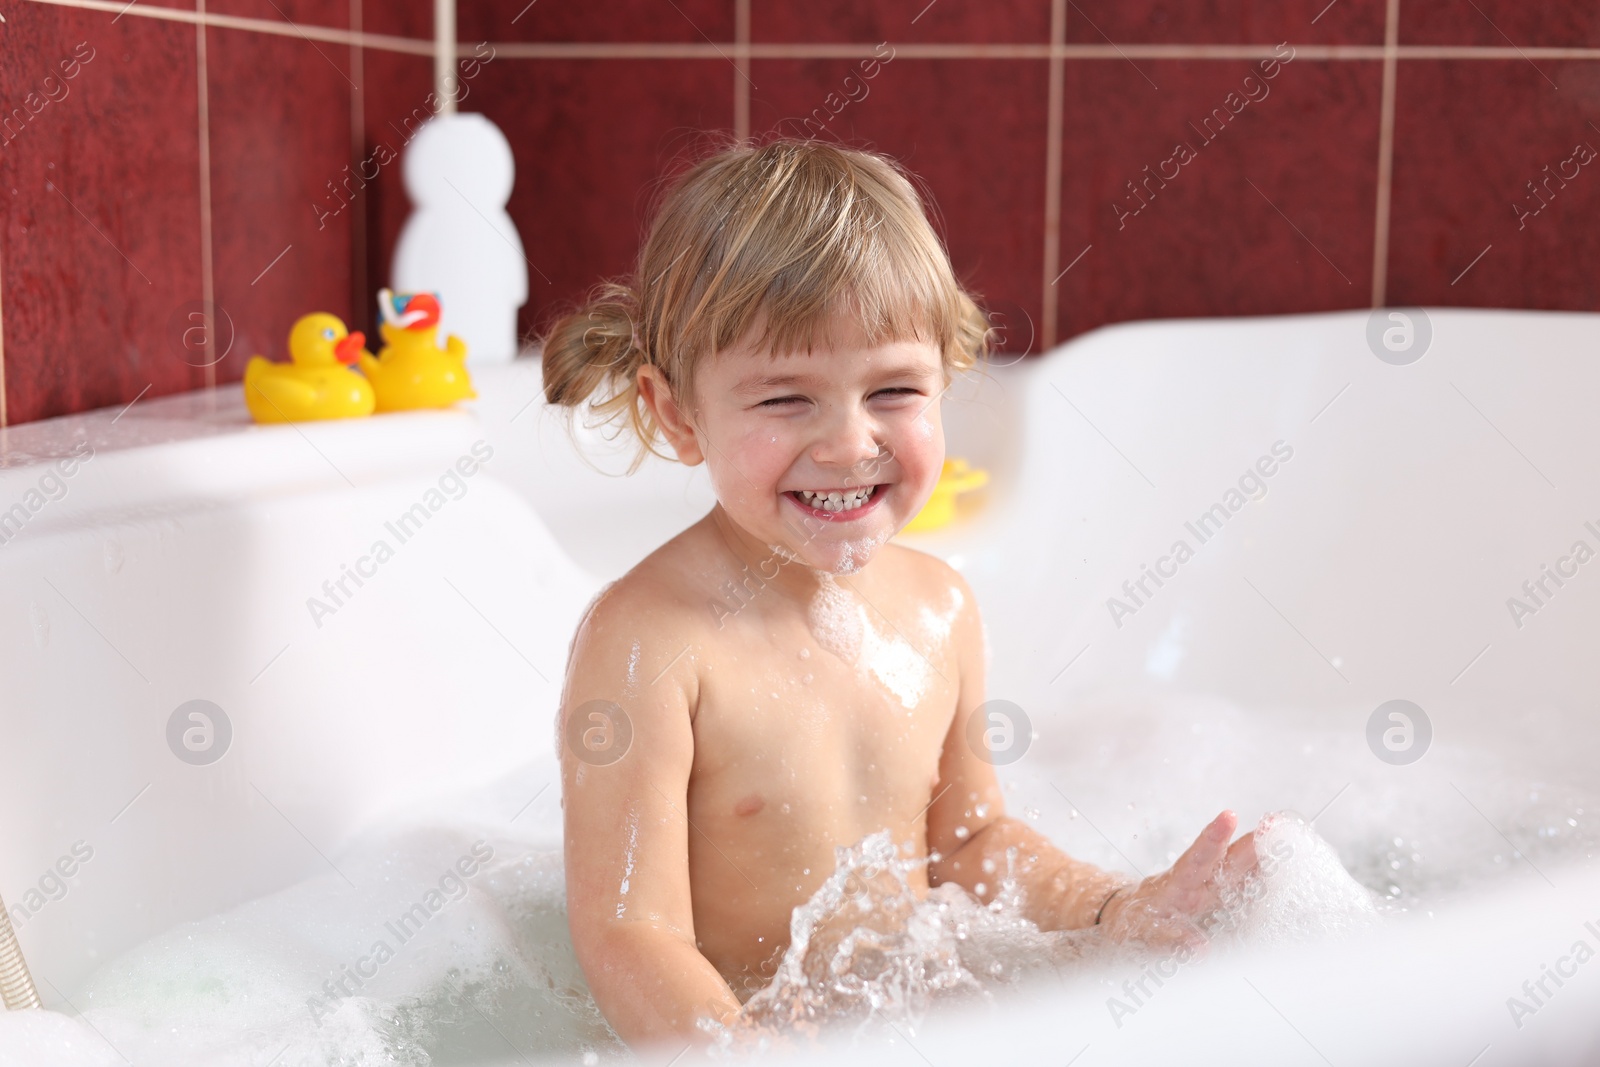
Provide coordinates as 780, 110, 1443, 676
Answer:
542, 139, 1256, 1043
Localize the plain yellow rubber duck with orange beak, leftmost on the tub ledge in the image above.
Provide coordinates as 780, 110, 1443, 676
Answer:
245, 312, 376, 422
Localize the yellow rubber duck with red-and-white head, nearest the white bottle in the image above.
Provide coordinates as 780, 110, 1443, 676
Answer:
362, 290, 478, 411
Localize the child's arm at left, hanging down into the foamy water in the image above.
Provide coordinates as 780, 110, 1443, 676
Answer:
558, 587, 739, 1045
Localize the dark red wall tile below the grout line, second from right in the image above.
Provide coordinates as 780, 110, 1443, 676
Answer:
1056, 58, 1382, 336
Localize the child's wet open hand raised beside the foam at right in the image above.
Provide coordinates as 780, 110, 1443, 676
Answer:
1099, 811, 1258, 949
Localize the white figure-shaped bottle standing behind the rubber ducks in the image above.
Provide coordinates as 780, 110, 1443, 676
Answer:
392, 114, 528, 366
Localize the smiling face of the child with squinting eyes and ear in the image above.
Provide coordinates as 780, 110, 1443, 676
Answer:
640, 307, 946, 574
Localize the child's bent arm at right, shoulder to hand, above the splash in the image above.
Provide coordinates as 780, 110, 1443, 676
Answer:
928, 571, 1254, 942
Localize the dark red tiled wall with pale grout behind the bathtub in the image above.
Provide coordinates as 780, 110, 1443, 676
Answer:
0, 0, 1600, 422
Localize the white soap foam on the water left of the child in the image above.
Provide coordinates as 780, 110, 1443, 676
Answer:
26, 829, 622, 1067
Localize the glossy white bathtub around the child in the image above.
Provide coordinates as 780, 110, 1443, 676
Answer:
0, 303, 1600, 1067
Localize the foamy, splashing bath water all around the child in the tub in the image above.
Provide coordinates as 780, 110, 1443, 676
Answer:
0, 687, 1600, 1067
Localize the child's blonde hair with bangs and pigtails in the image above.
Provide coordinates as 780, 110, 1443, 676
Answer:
542, 138, 989, 474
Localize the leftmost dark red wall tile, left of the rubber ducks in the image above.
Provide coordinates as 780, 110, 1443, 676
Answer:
0, 3, 205, 422
